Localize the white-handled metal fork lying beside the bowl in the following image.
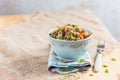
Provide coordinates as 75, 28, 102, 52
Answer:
94, 41, 105, 72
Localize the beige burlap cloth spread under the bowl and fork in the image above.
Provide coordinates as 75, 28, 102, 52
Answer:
0, 11, 120, 80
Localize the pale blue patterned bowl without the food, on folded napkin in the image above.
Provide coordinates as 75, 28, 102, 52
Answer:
49, 29, 92, 61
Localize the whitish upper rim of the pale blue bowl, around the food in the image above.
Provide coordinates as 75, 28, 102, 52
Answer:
48, 27, 93, 42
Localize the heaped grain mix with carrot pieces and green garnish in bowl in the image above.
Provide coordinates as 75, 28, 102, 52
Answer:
49, 24, 91, 41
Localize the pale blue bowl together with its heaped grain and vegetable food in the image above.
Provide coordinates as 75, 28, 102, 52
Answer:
49, 24, 93, 61
